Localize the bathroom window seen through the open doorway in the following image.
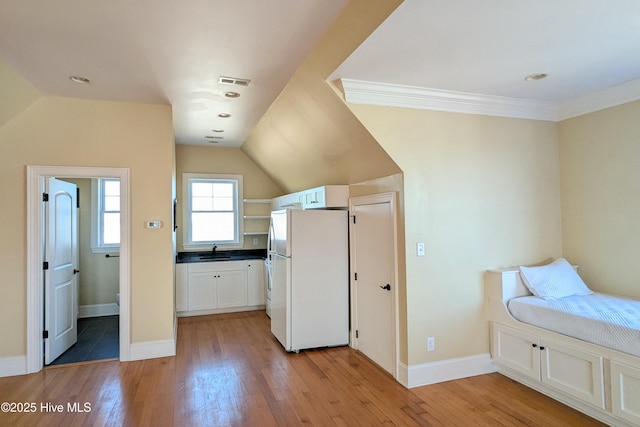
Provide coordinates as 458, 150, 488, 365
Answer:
91, 178, 120, 253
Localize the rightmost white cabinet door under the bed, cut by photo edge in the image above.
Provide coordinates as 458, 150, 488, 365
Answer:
611, 361, 640, 425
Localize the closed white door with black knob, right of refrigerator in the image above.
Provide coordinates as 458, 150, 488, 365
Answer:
350, 193, 397, 376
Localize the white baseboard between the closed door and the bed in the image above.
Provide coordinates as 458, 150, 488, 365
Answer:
404, 353, 498, 388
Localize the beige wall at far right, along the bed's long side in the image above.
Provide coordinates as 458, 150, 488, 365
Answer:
558, 101, 640, 298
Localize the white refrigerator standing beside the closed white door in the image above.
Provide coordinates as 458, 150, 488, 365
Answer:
269, 210, 349, 352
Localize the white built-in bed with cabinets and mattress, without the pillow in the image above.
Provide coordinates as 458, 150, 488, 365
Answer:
485, 268, 640, 426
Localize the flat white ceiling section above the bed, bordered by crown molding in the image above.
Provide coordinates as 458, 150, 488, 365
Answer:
330, 0, 640, 120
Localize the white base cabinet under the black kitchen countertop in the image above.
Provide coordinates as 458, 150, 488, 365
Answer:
176, 260, 265, 316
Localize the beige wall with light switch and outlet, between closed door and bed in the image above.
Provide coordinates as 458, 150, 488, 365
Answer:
350, 105, 562, 365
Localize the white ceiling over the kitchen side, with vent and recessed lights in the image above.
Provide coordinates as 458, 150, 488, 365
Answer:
0, 0, 347, 146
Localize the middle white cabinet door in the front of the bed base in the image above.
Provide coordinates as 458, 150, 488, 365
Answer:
540, 341, 605, 409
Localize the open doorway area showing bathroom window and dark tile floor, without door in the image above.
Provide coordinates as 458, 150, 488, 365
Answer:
44, 177, 120, 365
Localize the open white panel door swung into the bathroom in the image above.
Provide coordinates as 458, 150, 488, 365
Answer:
44, 178, 78, 365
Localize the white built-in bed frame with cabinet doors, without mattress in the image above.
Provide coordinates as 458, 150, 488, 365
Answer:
485, 268, 640, 427
